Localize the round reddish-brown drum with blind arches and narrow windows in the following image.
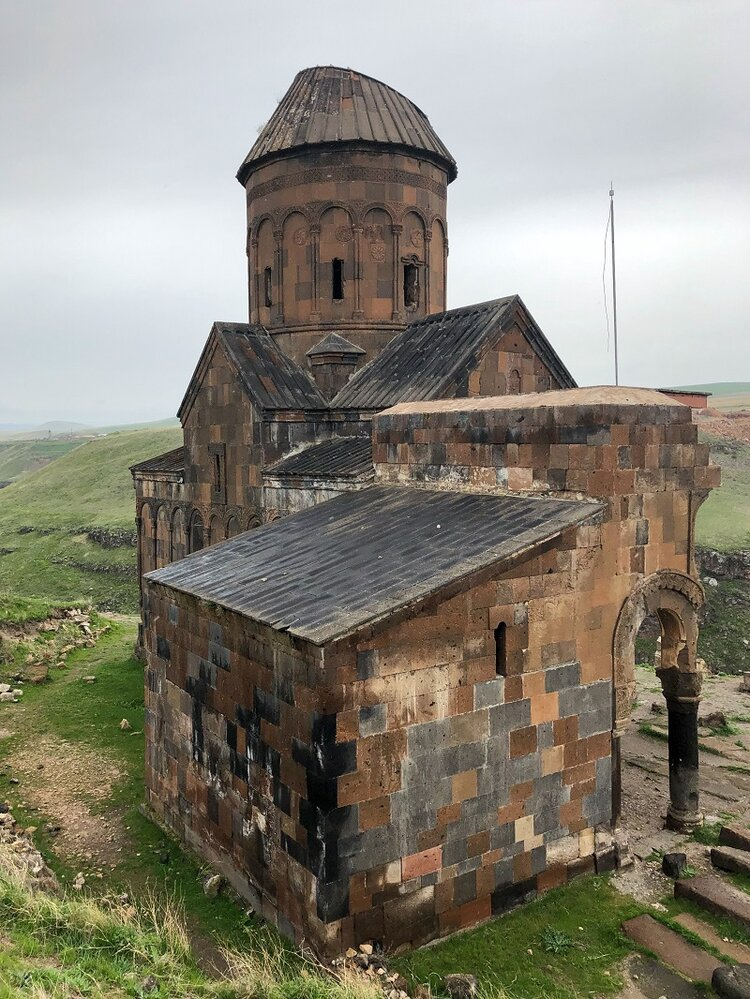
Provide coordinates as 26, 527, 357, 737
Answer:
246, 148, 448, 365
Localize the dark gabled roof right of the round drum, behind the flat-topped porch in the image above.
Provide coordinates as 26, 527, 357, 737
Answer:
331, 295, 576, 410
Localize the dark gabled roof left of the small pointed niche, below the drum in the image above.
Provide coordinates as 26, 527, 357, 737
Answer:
177, 323, 328, 421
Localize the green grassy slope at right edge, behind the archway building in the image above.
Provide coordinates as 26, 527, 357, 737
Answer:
695, 432, 750, 552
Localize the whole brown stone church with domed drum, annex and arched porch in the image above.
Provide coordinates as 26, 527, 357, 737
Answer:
132, 66, 718, 955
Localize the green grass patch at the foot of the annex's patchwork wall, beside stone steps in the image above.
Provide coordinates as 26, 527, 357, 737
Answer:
393, 877, 645, 999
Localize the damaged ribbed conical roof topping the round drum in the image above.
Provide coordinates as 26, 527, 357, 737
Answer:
237, 66, 458, 184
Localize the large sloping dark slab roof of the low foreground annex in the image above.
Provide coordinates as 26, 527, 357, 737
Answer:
146, 486, 604, 645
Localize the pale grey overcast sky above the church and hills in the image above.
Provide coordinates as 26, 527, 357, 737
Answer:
0, 0, 750, 424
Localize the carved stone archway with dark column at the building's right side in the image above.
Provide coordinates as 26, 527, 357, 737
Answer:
612, 569, 704, 831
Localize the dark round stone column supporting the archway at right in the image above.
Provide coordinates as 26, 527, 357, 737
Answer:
656, 667, 703, 832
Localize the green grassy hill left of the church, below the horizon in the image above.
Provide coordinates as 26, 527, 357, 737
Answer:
0, 429, 182, 612
